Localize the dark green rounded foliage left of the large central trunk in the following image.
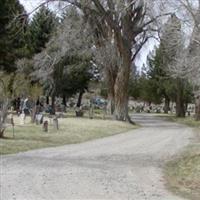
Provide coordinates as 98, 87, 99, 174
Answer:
54, 55, 92, 97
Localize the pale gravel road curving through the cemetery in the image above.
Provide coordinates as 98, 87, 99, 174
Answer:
0, 115, 192, 200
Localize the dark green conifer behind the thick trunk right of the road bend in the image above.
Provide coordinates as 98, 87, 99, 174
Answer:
145, 45, 192, 113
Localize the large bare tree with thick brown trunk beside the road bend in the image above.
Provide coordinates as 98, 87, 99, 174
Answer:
25, 0, 172, 121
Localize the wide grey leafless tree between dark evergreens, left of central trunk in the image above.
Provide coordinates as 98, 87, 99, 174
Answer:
32, 6, 91, 107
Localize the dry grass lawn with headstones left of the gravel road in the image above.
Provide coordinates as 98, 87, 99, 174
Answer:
0, 117, 136, 155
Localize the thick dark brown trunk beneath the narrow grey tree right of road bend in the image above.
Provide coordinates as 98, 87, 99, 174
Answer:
176, 79, 185, 117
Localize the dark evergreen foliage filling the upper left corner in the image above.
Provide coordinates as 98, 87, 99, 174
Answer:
0, 0, 27, 72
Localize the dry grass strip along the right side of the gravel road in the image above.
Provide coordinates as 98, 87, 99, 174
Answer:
165, 117, 200, 200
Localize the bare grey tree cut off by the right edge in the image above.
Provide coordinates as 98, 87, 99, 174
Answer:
163, 0, 200, 120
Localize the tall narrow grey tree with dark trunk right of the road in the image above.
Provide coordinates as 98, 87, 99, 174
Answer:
160, 14, 187, 117
